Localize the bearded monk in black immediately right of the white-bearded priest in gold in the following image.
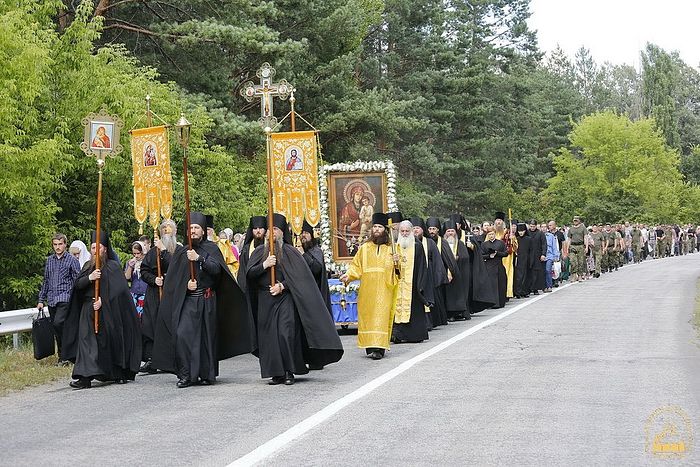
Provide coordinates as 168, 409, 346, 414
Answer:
411, 217, 447, 331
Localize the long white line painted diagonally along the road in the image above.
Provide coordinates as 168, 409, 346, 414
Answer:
228, 282, 573, 467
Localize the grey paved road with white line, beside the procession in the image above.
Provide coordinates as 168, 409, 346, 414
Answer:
0, 254, 700, 466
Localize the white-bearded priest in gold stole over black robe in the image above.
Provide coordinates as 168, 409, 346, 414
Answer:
392, 221, 432, 344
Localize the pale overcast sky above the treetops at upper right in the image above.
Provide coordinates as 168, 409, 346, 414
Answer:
528, 0, 700, 67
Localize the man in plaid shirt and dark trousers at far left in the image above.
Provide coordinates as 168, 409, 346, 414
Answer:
37, 233, 80, 364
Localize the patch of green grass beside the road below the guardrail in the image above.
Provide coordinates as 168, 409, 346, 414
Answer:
0, 346, 72, 396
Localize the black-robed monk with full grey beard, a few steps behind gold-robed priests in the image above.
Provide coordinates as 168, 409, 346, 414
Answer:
443, 219, 472, 321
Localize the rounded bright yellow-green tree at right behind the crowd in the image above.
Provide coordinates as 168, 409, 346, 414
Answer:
542, 112, 683, 222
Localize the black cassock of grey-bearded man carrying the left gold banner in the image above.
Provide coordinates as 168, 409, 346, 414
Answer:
141, 248, 170, 362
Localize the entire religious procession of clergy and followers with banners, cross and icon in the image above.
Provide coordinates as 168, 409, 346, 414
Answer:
24, 63, 700, 389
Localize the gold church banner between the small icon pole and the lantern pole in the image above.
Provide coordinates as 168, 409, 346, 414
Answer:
130, 126, 173, 230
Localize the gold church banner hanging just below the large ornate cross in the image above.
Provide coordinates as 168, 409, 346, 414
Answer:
270, 131, 321, 234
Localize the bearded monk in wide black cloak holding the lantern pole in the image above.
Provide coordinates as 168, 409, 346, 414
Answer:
153, 212, 254, 388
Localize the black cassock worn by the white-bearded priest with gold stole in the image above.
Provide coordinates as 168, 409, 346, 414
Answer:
392, 242, 430, 343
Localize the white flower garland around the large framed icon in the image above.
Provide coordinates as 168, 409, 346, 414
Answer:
318, 160, 399, 273
